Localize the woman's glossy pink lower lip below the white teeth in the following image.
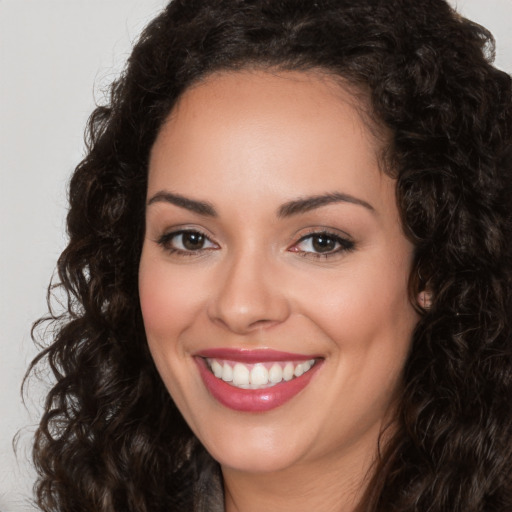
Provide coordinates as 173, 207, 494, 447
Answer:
195, 357, 321, 412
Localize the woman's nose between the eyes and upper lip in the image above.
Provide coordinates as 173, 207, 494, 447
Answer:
208, 249, 290, 334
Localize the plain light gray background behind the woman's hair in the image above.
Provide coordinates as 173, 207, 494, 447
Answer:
0, 0, 512, 512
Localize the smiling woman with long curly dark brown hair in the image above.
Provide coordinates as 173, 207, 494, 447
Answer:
31, 0, 512, 512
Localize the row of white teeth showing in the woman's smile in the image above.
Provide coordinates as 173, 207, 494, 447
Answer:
205, 358, 316, 389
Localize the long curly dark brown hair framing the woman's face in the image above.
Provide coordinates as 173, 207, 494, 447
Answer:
31, 0, 512, 512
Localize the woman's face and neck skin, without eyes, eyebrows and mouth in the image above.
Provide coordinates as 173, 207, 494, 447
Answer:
139, 70, 418, 512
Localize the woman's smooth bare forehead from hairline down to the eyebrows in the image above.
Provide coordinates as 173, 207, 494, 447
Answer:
149, 70, 387, 212
